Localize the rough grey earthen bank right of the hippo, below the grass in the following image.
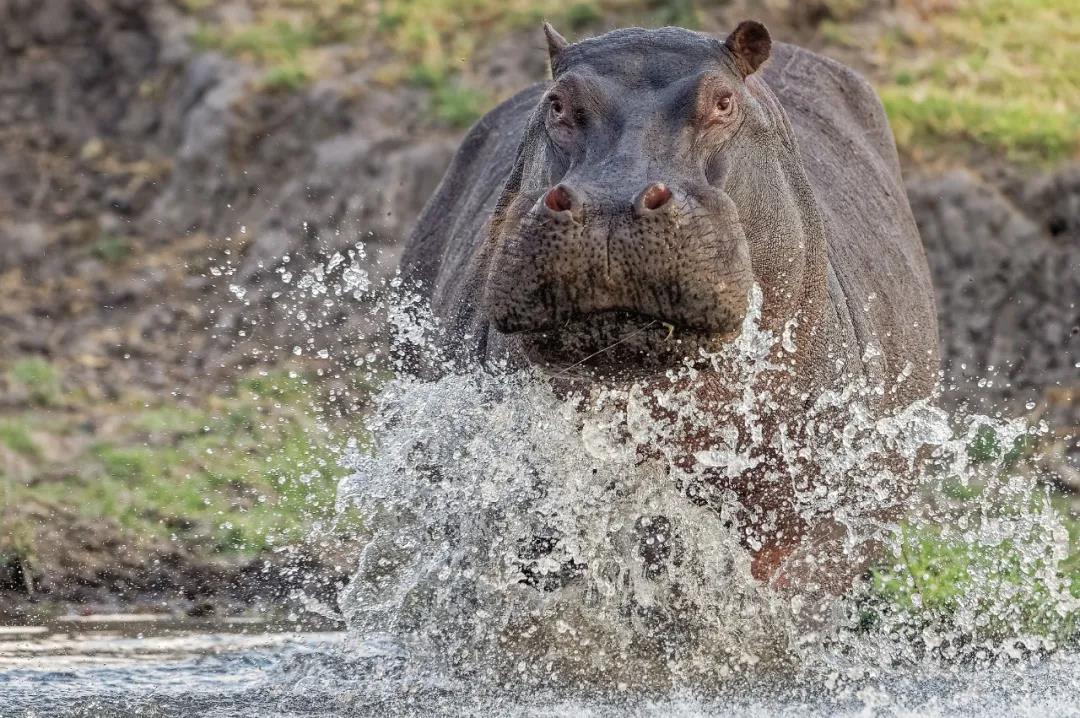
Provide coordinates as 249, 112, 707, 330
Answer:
908, 167, 1080, 442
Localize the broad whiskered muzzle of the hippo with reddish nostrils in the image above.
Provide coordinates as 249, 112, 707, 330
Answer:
485, 181, 752, 369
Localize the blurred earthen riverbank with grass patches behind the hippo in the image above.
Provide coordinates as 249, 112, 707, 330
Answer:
0, 0, 1080, 620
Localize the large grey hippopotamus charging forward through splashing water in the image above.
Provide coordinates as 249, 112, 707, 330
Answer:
402, 21, 939, 600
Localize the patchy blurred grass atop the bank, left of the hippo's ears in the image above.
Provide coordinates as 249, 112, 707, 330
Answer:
187, 0, 617, 130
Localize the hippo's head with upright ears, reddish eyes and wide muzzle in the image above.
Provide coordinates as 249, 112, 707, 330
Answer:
484, 22, 801, 370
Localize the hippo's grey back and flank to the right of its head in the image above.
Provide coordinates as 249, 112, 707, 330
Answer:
764, 43, 939, 399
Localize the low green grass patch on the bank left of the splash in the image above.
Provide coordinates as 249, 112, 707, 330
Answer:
0, 365, 367, 570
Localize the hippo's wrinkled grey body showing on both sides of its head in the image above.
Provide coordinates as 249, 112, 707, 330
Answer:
402, 36, 939, 401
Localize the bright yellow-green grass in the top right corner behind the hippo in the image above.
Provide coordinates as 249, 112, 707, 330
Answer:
880, 0, 1080, 164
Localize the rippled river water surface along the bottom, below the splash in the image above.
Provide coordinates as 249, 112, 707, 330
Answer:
0, 626, 1080, 718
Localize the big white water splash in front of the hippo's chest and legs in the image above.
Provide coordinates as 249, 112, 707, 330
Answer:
326, 273, 1080, 695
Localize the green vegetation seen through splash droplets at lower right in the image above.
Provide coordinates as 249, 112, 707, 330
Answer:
862, 424, 1080, 642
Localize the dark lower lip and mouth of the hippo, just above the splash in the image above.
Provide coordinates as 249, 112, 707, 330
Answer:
512, 310, 738, 378
